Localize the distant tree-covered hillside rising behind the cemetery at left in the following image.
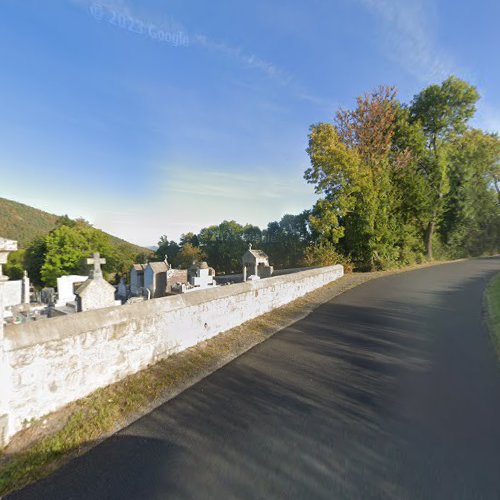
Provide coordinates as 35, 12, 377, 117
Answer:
0, 198, 151, 254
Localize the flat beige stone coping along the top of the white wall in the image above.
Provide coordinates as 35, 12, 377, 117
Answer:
4, 265, 343, 351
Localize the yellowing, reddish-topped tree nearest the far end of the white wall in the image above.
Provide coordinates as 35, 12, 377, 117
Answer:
305, 87, 404, 269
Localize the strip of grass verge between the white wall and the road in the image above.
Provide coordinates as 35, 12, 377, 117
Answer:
0, 262, 460, 497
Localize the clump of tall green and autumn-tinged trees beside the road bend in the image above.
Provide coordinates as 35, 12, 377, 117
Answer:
305, 77, 500, 270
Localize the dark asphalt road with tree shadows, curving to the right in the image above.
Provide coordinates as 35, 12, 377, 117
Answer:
8, 258, 500, 500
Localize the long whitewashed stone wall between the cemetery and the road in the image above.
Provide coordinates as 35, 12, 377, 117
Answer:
2, 266, 343, 437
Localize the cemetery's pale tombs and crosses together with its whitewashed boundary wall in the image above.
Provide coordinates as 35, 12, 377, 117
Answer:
0, 233, 343, 444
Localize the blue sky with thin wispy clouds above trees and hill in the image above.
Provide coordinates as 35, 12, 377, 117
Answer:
0, 0, 500, 245
